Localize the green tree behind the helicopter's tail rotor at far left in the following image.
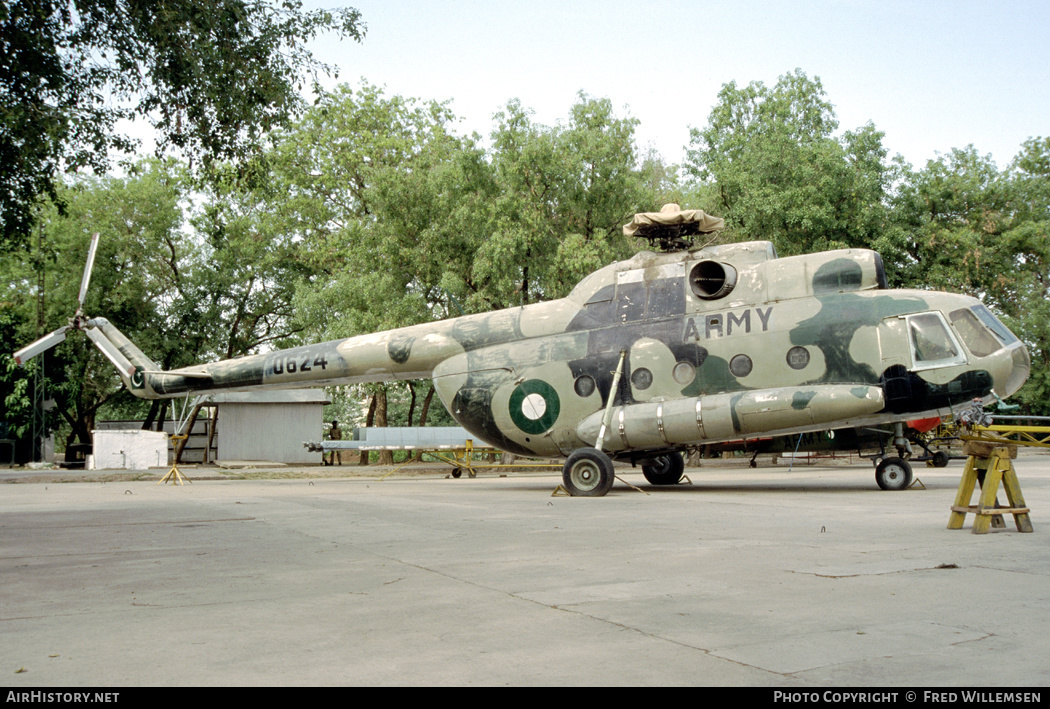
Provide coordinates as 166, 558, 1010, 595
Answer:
4, 161, 202, 457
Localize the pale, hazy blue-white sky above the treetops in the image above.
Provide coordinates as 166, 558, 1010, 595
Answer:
303, 0, 1050, 169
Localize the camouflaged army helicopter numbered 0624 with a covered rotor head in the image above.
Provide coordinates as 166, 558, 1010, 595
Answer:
15, 205, 1031, 497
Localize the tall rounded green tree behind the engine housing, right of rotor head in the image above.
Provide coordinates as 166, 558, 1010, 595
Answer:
686, 69, 896, 263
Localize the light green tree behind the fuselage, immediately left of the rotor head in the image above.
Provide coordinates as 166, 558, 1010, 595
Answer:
475, 93, 651, 307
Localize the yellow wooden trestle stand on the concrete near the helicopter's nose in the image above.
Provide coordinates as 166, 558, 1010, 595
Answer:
948, 443, 1032, 535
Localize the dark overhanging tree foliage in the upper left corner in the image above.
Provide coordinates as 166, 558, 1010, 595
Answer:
0, 0, 364, 249
